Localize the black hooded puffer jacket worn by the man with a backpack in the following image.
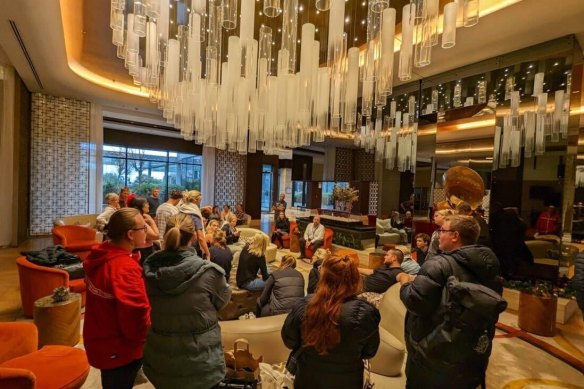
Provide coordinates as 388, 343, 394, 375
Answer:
400, 245, 503, 389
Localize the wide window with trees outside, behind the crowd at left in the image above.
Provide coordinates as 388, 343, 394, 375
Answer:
103, 145, 201, 199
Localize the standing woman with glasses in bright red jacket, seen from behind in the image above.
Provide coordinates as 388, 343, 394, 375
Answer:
83, 208, 150, 389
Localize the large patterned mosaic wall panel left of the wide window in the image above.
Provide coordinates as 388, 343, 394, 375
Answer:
30, 93, 90, 235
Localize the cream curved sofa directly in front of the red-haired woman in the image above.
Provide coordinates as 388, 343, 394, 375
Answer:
219, 284, 406, 389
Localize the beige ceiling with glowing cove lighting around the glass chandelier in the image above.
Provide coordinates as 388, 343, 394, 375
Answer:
0, 0, 584, 124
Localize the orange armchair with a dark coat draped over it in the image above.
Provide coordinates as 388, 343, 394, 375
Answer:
16, 257, 86, 317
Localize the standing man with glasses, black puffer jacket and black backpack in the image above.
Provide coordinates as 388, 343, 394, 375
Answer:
397, 215, 507, 389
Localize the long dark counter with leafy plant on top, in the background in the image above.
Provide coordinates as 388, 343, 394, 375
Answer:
296, 215, 375, 250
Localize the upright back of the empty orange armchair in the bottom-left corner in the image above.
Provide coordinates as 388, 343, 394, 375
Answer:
0, 322, 38, 360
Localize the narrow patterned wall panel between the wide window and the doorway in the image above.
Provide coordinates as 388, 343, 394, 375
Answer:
214, 150, 247, 209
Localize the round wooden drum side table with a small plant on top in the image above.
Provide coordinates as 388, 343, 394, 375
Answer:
33, 293, 81, 348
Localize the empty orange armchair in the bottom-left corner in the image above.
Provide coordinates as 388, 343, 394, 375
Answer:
0, 322, 89, 389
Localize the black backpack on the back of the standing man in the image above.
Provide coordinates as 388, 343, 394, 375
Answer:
414, 256, 507, 366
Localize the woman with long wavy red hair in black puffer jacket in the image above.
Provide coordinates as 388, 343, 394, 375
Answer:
282, 256, 381, 389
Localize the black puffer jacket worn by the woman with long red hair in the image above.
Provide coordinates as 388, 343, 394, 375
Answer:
282, 295, 381, 389
